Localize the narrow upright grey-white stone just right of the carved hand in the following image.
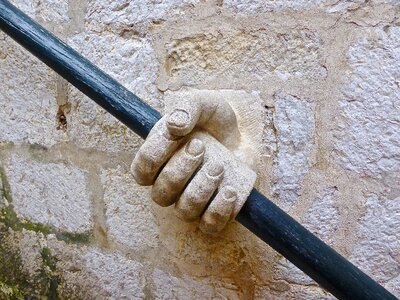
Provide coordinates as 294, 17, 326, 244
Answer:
274, 94, 315, 208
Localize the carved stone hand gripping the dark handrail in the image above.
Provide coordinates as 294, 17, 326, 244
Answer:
131, 91, 256, 233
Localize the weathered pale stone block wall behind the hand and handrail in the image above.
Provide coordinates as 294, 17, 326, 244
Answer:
0, 0, 400, 299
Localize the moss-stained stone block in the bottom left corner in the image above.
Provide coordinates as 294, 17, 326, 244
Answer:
8, 229, 146, 300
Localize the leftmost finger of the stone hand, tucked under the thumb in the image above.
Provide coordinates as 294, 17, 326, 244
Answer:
131, 117, 183, 185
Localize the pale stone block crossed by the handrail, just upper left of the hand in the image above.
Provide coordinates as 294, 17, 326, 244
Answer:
67, 33, 161, 152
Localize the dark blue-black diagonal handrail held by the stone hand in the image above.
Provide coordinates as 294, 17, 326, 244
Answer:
0, 0, 396, 300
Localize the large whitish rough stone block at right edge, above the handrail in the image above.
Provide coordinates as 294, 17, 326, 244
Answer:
336, 27, 400, 178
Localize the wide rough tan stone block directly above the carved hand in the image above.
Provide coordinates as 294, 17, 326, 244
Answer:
164, 29, 327, 85
